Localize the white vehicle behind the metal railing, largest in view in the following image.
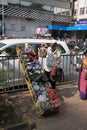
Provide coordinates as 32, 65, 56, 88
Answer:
0, 39, 71, 86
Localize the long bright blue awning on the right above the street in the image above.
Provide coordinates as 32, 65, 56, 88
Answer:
48, 25, 87, 31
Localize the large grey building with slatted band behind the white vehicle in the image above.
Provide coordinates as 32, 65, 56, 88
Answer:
0, 0, 73, 37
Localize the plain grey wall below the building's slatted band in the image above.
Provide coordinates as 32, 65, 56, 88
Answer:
5, 16, 51, 37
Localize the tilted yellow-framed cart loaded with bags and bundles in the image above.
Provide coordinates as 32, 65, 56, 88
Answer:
16, 47, 61, 117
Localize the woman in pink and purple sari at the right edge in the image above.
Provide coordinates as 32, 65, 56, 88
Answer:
79, 50, 87, 99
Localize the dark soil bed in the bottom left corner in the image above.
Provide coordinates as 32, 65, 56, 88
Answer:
0, 94, 23, 127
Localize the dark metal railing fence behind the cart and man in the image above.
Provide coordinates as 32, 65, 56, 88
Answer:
0, 55, 81, 93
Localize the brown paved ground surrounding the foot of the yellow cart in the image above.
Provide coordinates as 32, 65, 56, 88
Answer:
9, 83, 87, 130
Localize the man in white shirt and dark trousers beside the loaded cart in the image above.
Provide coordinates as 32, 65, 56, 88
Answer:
44, 43, 61, 89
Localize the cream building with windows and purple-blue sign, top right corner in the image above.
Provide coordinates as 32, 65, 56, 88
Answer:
74, 0, 87, 40
